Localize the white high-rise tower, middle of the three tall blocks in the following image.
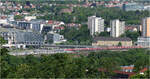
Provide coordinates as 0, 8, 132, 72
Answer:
110, 19, 125, 37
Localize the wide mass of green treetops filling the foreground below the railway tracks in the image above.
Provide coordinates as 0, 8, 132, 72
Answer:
0, 48, 149, 78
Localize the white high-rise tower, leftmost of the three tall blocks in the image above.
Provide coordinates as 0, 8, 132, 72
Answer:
88, 16, 104, 35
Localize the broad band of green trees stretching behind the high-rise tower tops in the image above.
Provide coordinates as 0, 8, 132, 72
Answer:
38, 6, 150, 26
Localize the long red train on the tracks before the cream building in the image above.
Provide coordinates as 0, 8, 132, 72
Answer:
64, 46, 142, 51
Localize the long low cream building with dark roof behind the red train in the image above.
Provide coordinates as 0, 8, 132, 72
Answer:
92, 37, 132, 46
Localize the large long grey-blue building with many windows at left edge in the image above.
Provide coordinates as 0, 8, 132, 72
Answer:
0, 29, 44, 46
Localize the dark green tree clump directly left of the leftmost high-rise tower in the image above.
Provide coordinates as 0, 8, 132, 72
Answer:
60, 25, 92, 45
